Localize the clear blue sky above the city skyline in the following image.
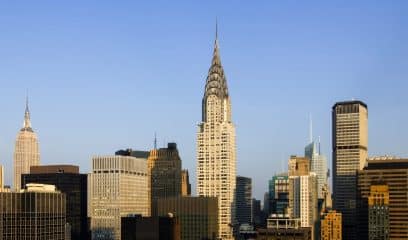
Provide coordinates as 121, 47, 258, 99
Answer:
0, 1, 408, 201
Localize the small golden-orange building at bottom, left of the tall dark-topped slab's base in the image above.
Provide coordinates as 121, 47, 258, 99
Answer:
320, 211, 342, 240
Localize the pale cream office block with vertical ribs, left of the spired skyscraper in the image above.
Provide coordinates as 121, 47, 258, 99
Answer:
88, 155, 150, 240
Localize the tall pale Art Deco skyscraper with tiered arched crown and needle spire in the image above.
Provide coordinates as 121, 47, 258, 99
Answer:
197, 25, 236, 240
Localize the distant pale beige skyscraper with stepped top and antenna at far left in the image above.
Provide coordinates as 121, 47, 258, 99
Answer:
14, 100, 40, 191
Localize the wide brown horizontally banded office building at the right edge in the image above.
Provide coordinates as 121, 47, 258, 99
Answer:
357, 157, 408, 239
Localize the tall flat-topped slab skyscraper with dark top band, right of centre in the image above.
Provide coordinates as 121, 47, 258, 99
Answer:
332, 101, 368, 240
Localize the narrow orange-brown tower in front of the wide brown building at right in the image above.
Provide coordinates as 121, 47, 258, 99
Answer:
368, 185, 390, 240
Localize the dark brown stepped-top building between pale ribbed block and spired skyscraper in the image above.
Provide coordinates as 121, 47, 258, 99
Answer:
147, 143, 181, 215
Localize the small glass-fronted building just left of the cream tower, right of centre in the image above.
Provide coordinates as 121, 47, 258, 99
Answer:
270, 173, 289, 214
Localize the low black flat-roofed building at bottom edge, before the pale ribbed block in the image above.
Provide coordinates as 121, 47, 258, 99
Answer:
121, 215, 181, 240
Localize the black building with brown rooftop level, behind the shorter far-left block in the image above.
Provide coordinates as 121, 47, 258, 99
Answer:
21, 165, 88, 239
